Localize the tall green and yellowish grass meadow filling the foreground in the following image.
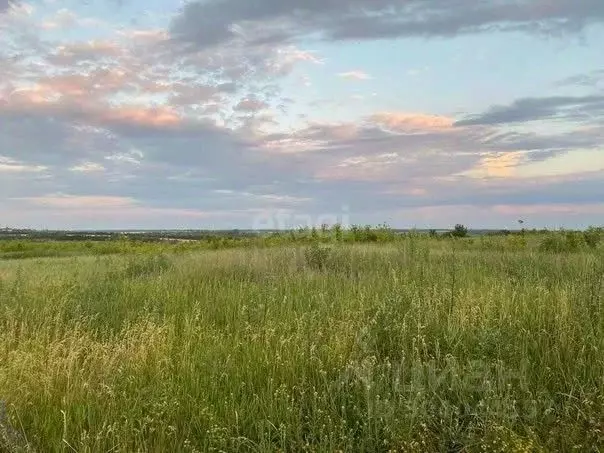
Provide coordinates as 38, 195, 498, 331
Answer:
0, 236, 604, 452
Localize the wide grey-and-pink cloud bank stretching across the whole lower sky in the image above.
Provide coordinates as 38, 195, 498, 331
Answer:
0, 41, 602, 225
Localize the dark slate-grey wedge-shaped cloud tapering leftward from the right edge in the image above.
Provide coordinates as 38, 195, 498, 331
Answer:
455, 94, 604, 126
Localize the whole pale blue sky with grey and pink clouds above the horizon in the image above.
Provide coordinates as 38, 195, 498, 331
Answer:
0, 0, 604, 229
